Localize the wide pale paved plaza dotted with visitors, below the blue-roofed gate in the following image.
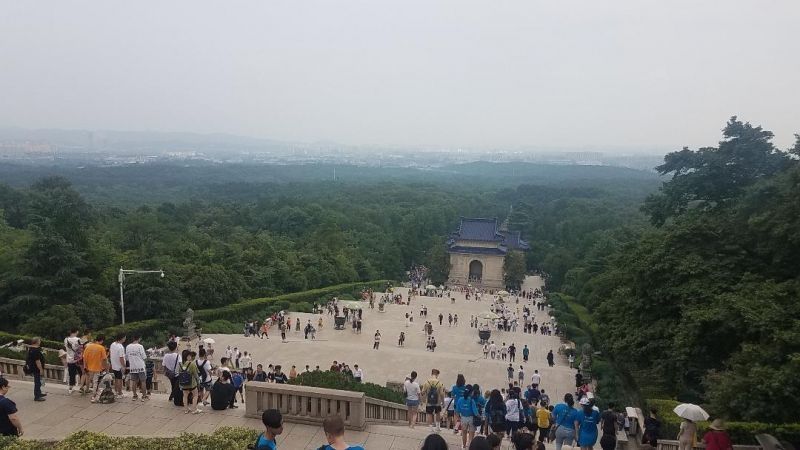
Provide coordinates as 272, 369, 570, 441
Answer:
204, 277, 574, 401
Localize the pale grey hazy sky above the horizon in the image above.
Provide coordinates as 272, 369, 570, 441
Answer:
0, 0, 800, 148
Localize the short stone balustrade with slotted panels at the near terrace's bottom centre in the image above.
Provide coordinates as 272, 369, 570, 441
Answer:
245, 381, 366, 430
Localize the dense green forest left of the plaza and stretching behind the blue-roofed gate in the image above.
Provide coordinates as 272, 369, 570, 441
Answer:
0, 164, 657, 338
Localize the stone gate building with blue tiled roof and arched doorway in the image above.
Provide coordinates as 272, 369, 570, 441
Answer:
447, 217, 530, 289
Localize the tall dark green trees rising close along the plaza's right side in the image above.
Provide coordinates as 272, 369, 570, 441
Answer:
555, 118, 800, 423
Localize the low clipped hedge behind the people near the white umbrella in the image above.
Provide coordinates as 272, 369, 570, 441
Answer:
644, 399, 800, 445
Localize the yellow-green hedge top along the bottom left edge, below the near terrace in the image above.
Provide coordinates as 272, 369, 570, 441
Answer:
0, 427, 260, 450
